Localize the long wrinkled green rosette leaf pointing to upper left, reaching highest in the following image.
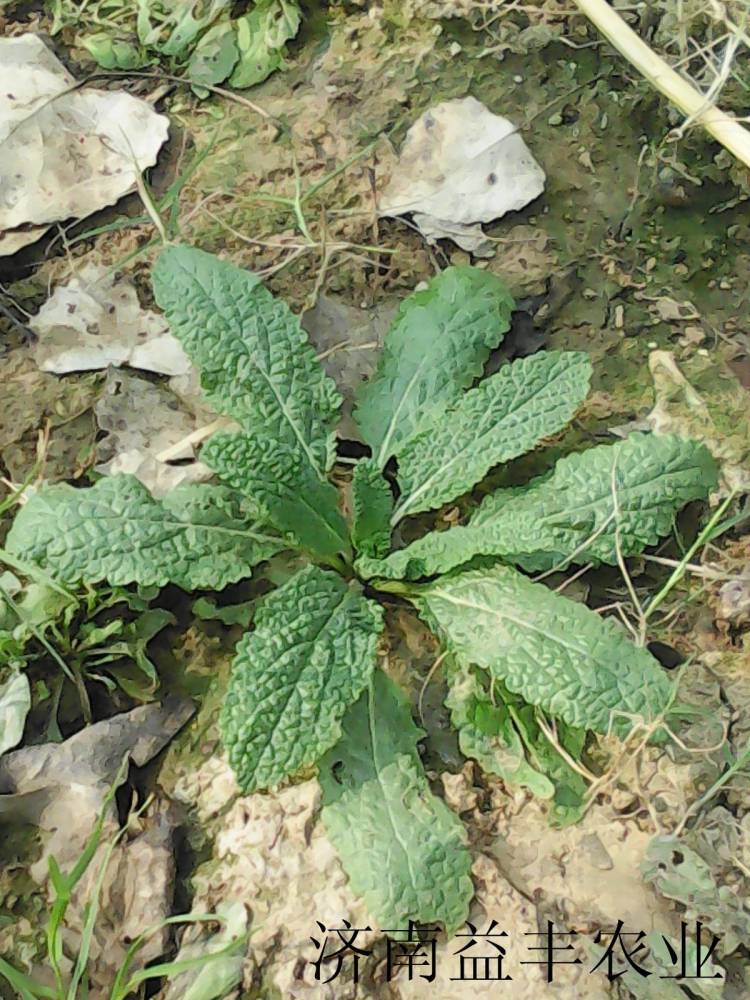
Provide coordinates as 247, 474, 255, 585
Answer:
153, 247, 341, 480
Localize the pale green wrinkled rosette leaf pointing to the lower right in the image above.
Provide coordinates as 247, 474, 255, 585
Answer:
418, 566, 671, 736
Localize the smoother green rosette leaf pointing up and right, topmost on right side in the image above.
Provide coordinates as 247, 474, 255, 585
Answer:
354, 267, 514, 469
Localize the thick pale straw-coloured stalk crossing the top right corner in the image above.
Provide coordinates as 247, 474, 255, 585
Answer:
575, 0, 750, 167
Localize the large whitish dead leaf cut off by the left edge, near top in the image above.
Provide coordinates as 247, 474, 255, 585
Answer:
0, 34, 169, 256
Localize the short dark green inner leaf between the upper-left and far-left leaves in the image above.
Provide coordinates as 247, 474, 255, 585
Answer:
201, 433, 349, 559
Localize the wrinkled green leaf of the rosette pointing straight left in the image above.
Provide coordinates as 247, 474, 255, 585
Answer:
5, 475, 286, 590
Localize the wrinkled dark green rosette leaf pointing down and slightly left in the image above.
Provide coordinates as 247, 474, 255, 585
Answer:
220, 566, 383, 793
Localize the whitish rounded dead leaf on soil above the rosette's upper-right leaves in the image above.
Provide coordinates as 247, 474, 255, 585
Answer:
378, 97, 545, 254
